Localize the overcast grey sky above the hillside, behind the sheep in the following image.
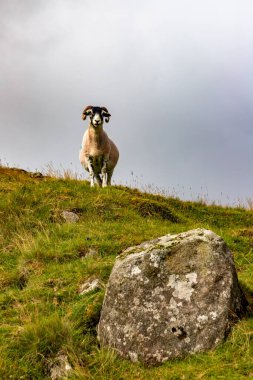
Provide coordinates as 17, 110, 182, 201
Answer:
0, 0, 253, 203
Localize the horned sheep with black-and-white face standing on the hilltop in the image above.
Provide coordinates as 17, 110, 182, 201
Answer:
79, 106, 119, 187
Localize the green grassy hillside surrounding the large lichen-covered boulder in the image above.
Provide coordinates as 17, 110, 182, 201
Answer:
0, 167, 253, 380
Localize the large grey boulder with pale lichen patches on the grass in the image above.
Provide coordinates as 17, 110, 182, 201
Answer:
98, 229, 246, 365
